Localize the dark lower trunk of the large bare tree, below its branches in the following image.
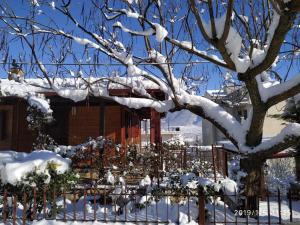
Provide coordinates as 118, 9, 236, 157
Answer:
240, 157, 265, 211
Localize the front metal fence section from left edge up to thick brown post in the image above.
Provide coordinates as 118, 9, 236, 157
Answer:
0, 185, 205, 225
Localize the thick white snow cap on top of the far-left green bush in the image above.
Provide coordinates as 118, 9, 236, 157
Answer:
0, 150, 71, 185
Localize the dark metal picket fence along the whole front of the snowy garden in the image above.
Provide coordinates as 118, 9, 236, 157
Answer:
0, 185, 300, 225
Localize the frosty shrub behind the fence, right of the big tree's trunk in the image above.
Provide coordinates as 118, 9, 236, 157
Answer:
266, 158, 295, 194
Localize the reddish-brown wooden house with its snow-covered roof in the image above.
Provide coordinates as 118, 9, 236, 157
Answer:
0, 79, 165, 152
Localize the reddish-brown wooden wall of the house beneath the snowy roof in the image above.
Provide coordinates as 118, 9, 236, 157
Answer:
0, 99, 141, 152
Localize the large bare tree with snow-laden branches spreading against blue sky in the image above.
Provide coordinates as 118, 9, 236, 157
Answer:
0, 0, 300, 208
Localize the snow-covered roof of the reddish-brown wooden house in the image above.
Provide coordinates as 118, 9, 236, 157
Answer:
0, 77, 164, 102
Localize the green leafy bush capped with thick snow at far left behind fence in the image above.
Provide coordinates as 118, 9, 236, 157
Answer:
0, 150, 78, 216
